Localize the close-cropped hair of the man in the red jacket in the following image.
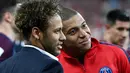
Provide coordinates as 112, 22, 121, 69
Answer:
59, 5, 77, 21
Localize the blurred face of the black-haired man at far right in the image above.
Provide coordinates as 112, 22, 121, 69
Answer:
108, 20, 130, 46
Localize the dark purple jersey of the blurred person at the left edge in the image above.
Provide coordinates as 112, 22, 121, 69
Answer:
0, 33, 14, 62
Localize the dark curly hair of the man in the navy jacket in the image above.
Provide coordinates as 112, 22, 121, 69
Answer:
16, 0, 59, 40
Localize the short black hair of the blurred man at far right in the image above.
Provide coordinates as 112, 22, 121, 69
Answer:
106, 9, 130, 25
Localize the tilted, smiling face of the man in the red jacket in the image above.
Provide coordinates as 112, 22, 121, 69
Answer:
63, 13, 91, 52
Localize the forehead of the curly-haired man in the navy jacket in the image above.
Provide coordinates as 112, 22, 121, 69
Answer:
48, 14, 63, 29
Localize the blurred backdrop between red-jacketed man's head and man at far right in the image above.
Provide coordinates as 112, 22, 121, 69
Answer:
60, 0, 130, 40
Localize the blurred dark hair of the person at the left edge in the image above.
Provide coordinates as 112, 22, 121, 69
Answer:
0, 0, 17, 21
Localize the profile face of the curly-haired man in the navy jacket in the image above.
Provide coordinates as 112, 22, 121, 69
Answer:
43, 14, 66, 55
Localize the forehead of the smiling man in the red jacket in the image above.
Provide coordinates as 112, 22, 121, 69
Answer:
63, 13, 85, 30
